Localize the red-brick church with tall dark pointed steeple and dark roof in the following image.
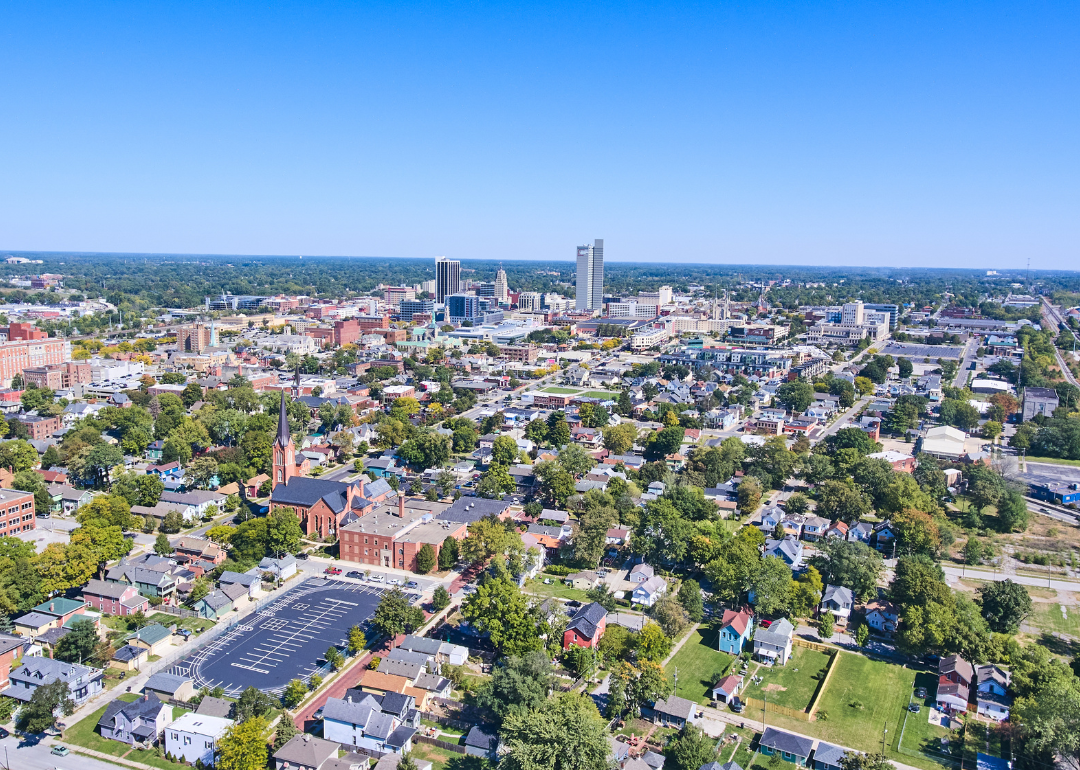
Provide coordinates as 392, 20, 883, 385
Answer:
270, 370, 391, 539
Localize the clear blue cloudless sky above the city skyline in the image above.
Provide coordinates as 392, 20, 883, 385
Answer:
0, 0, 1080, 268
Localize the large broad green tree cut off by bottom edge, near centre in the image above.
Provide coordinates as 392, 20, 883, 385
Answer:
500, 692, 610, 770
